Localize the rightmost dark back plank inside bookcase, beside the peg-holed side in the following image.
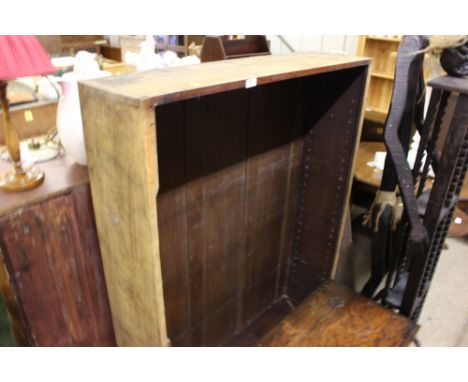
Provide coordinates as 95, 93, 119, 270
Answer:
242, 80, 305, 323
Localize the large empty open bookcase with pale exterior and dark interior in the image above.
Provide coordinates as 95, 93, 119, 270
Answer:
80, 54, 369, 345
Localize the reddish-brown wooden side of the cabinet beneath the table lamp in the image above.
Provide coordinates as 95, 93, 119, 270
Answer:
0, 185, 115, 346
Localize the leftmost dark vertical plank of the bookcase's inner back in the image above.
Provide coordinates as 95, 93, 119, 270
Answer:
157, 102, 191, 339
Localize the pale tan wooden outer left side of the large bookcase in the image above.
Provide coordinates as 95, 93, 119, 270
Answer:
80, 86, 167, 346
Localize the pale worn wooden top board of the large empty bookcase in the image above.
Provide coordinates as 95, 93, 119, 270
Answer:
82, 53, 369, 106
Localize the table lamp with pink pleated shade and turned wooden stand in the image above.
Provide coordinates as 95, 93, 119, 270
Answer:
0, 35, 57, 191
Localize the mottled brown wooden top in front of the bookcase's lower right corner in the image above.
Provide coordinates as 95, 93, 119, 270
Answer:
258, 282, 418, 346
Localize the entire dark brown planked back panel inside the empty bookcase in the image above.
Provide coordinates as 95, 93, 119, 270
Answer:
156, 80, 312, 345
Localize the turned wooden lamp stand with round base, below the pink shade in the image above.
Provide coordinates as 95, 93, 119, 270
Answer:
0, 81, 44, 192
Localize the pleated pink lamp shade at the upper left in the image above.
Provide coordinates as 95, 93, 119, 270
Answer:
0, 35, 57, 80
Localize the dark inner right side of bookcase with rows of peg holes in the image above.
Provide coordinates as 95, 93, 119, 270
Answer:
286, 70, 366, 302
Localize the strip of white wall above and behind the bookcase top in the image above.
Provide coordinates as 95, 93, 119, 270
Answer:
267, 35, 359, 55
